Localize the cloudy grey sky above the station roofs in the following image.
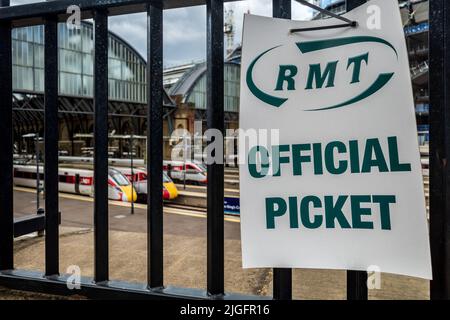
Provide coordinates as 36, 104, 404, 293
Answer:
11, 0, 311, 67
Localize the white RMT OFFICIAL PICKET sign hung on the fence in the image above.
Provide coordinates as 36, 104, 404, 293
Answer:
239, 0, 431, 279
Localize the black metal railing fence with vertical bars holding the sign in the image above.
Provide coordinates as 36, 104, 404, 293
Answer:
0, 0, 450, 300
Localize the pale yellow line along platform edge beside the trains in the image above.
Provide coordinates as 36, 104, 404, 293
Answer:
14, 187, 241, 223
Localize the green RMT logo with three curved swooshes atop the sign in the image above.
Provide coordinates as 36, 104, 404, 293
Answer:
246, 36, 398, 111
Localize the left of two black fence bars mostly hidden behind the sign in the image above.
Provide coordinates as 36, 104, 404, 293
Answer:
272, 0, 292, 300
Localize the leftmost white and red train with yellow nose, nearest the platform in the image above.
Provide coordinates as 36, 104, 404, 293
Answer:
13, 165, 137, 202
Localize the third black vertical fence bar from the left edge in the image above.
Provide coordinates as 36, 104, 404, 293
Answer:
94, 9, 109, 282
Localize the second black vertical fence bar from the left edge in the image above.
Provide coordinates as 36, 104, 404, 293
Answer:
43, 13, 59, 276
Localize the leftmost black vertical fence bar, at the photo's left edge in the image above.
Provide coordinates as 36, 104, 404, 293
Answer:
0, 0, 14, 270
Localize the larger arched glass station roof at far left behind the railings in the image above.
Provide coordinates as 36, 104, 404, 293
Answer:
12, 22, 147, 103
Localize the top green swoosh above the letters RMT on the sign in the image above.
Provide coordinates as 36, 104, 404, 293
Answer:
296, 36, 398, 58
